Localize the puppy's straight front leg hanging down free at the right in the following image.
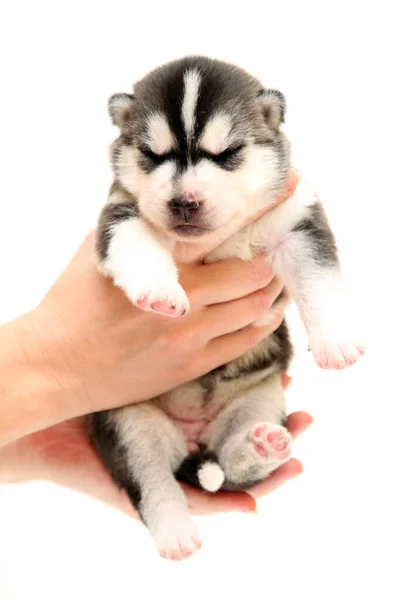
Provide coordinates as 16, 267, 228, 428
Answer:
270, 200, 364, 369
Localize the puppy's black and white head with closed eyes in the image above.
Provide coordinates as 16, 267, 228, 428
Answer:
109, 57, 289, 240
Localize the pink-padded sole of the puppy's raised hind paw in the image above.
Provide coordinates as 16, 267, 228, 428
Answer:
250, 423, 292, 462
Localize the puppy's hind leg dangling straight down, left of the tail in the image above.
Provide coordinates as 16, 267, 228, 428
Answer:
92, 402, 201, 560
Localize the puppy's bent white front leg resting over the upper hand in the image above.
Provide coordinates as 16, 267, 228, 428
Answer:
96, 184, 189, 317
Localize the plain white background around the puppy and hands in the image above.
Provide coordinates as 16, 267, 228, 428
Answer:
0, 0, 400, 600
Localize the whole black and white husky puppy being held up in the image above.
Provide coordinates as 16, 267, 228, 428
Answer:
90, 57, 363, 559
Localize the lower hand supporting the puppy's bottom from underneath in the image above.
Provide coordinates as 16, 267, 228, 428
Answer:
0, 377, 312, 518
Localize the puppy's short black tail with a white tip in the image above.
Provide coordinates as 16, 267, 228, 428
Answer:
175, 450, 225, 492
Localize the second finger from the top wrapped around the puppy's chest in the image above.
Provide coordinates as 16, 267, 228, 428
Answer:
201, 277, 282, 340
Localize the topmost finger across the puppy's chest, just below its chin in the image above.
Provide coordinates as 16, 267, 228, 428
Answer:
182, 255, 274, 306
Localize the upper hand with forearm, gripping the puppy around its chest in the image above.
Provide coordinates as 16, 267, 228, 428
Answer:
0, 174, 297, 445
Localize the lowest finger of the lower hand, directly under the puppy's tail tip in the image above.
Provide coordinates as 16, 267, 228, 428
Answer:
181, 483, 257, 515
